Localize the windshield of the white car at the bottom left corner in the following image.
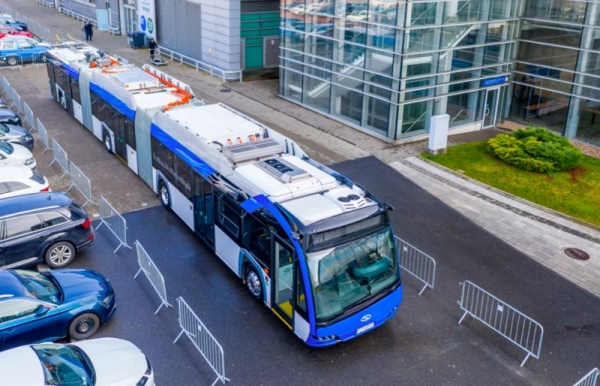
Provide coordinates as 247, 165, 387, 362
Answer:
31, 344, 96, 386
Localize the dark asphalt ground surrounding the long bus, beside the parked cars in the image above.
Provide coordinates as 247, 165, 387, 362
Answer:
2, 3, 600, 386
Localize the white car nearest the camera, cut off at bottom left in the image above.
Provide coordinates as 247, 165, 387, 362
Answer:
0, 338, 154, 386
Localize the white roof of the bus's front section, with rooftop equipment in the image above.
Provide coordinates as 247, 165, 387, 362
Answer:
153, 104, 377, 225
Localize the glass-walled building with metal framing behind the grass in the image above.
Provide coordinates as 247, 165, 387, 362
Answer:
279, 0, 600, 144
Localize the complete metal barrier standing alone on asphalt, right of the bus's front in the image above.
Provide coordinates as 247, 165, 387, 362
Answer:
458, 280, 544, 367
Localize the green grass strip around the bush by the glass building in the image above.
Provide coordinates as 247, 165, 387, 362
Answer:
422, 141, 600, 226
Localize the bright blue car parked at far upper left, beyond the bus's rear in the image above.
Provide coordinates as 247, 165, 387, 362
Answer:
0, 35, 52, 66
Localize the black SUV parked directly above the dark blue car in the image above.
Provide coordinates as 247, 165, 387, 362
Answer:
0, 192, 95, 269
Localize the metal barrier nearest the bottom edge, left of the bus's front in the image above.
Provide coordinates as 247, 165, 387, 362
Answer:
173, 297, 230, 386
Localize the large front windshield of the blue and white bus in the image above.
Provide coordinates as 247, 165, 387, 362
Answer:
307, 227, 400, 323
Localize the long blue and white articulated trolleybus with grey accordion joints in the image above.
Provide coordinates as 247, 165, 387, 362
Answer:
48, 43, 402, 347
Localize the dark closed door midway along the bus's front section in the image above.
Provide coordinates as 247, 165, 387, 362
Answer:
192, 171, 215, 249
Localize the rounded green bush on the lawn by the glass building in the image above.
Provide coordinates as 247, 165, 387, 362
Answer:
488, 127, 582, 173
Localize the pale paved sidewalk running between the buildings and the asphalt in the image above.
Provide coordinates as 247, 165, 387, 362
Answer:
5, 0, 600, 297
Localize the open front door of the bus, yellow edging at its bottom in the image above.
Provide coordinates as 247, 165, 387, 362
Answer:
271, 234, 294, 328
